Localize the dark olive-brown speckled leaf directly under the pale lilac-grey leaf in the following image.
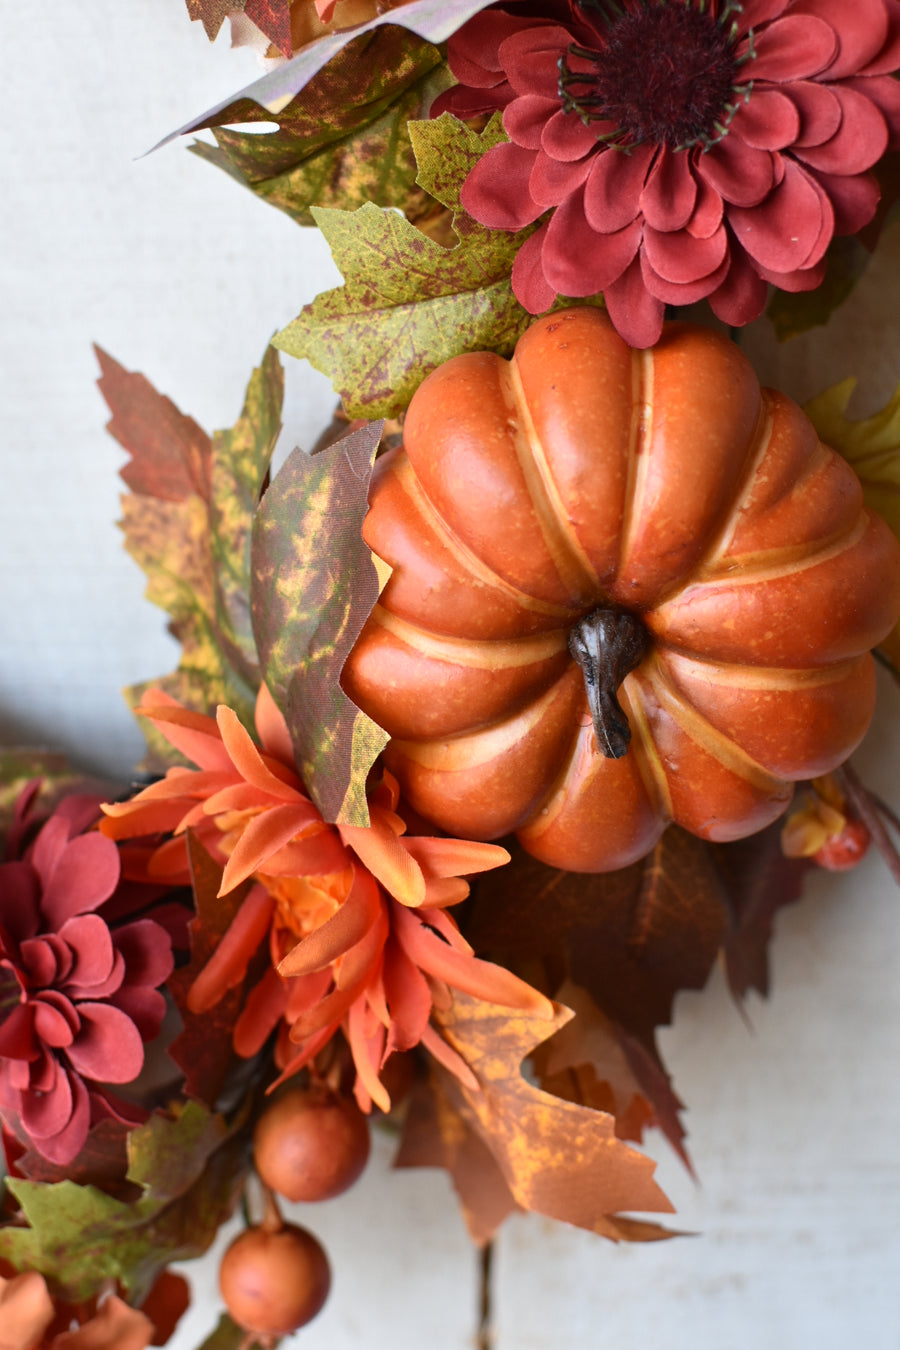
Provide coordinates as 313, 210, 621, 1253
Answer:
190, 27, 452, 225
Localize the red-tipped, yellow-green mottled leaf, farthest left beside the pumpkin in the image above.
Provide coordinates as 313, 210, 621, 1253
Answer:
97, 348, 283, 768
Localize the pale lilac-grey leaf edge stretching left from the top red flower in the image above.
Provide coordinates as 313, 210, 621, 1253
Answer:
154, 0, 504, 150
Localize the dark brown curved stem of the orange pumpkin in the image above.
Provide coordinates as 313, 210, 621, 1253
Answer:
569, 609, 648, 759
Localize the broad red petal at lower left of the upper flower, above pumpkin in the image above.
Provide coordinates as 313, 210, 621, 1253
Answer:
542, 189, 642, 298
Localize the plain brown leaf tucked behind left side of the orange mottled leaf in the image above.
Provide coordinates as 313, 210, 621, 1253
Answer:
394, 1071, 519, 1246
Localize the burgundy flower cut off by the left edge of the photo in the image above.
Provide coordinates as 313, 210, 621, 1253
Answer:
0, 810, 173, 1164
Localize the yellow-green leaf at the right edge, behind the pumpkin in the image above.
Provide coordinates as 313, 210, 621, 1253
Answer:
804, 377, 900, 679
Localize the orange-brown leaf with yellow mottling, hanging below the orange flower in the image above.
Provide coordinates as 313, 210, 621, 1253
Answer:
434, 994, 672, 1241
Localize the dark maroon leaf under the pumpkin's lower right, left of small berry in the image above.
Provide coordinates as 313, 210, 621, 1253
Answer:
712, 821, 812, 999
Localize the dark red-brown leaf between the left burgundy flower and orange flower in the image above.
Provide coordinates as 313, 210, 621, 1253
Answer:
167, 834, 259, 1106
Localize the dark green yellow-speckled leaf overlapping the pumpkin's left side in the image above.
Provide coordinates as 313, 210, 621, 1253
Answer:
251, 424, 387, 825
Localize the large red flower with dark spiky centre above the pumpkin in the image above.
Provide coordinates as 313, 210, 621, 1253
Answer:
433, 0, 900, 347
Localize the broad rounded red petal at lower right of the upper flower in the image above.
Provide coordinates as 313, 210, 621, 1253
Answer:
727, 161, 834, 273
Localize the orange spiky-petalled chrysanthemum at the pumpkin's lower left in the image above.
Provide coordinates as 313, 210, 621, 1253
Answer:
103, 686, 552, 1110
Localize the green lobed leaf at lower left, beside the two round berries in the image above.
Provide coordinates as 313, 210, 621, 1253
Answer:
0, 1102, 247, 1304
